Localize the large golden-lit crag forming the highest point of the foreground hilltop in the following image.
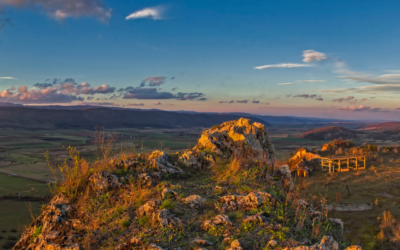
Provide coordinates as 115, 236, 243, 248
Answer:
193, 118, 275, 164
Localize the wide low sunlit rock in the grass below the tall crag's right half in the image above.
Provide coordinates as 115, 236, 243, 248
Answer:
219, 192, 272, 212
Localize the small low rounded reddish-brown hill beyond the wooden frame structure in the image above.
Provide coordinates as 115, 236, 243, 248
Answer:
300, 126, 357, 140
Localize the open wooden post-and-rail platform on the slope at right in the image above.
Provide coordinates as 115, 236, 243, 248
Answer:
321, 155, 366, 173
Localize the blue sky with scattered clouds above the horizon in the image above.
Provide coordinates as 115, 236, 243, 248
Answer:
0, 0, 400, 120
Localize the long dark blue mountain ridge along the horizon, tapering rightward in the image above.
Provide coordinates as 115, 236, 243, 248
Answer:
0, 103, 390, 129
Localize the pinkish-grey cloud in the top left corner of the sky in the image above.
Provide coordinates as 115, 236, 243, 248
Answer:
0, 0, 111, 22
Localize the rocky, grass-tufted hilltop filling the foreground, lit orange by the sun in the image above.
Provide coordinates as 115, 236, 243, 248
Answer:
14, 118, 361, 250
